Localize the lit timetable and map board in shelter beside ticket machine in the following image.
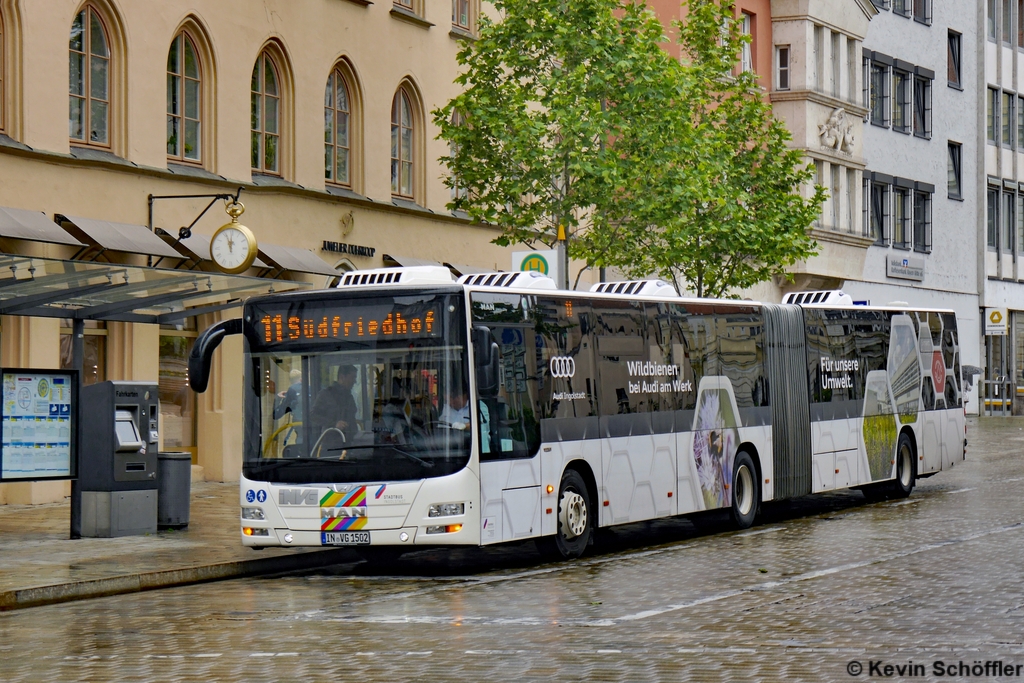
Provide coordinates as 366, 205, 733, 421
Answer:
0, 371, 72, 479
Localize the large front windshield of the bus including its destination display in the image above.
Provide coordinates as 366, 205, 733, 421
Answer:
243, 292, 472, 483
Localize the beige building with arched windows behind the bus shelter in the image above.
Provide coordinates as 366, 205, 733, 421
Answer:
0, 0, 509, 504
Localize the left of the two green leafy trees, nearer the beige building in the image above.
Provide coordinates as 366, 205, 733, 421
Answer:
433, 0, 674, 253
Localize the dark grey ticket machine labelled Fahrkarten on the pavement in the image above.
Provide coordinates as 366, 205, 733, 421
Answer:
73, 382, 160, 538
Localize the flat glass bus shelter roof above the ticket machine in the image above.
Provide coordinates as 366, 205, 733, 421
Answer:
0, 253, 310, 324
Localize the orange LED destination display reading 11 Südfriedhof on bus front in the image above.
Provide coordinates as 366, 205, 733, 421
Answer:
252, 301, 441, 346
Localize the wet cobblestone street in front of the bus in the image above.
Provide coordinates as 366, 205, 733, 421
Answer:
0, 419, 1024, 681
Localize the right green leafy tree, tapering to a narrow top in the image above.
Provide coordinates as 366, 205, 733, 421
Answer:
577, 0, 824, 297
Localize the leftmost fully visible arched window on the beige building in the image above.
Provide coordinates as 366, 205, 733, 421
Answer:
68, 5, 111, 147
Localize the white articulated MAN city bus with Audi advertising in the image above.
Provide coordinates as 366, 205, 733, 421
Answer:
189, 267, 965, 557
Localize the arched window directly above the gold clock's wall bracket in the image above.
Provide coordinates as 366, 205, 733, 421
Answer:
167, 31, 203, 162
